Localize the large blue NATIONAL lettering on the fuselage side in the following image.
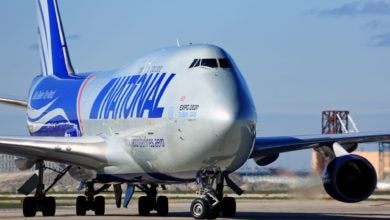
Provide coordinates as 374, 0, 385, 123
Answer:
90, 73, 176, 119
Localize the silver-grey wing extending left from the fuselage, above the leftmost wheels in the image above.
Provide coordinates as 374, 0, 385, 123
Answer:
0, 136, 106, 170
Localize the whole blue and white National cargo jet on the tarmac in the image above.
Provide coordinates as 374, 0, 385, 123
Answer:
0, 0, 390, 219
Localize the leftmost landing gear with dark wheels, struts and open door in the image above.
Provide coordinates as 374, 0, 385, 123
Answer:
19, 160, 71, 217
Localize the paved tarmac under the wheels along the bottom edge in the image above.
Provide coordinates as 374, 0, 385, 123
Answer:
0, 199, 390, 220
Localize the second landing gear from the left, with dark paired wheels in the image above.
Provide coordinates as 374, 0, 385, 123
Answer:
76, 182, 110, 216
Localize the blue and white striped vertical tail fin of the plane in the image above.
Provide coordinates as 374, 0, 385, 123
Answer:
37, 0, 74, 78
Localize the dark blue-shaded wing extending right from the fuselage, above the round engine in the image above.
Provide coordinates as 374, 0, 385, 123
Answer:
250, 132, 390, 158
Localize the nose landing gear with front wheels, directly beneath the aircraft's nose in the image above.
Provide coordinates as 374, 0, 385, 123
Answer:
191, 171, 242, 219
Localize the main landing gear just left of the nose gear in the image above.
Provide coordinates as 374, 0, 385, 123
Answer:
137, 184, 169, 216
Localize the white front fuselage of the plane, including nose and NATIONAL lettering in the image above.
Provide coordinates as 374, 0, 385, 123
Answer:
29, 45, 256, 182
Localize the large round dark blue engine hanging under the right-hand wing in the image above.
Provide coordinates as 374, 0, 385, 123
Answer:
322, 154, 377, 203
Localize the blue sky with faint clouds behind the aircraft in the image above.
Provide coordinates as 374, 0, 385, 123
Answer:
0, 0, 390, 169
